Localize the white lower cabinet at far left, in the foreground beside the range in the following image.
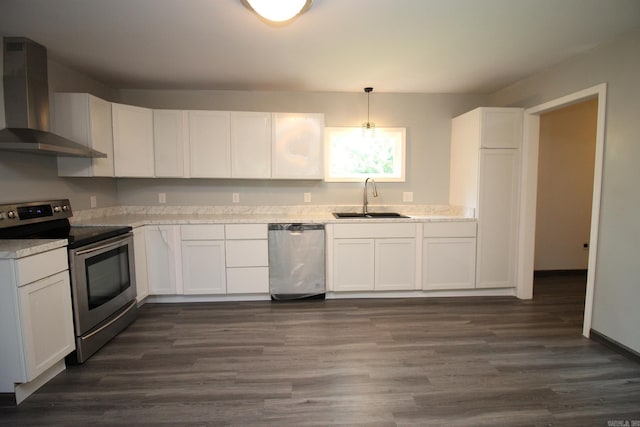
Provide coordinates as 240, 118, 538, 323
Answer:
0, 247, 75, 403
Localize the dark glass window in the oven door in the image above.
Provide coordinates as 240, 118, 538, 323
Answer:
85, 246, 131, 310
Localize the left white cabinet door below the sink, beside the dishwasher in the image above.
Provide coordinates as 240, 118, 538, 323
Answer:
333, 239, 375, 292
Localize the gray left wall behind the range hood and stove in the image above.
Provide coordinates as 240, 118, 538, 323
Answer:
0, 39, 118, 210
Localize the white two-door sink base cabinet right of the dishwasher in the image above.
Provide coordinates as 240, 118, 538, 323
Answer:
332, 223, 417, 292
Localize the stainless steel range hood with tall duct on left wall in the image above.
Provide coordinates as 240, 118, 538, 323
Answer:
0, 37, 107, 157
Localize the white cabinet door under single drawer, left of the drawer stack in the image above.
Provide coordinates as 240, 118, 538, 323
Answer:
182, 240, 227, 295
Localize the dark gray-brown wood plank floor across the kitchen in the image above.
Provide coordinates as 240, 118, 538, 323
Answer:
0, 276, 640, 426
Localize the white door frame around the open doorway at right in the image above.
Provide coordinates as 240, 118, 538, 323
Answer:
516, 83, 607, 337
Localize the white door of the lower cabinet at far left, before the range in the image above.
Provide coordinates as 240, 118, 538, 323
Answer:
19, 270, 75, 381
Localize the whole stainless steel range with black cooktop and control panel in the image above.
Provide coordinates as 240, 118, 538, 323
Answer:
0, 199, 137, 363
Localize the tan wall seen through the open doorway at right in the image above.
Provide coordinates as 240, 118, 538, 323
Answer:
534, 99, 598, 271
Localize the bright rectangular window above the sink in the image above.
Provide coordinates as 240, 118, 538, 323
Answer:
324, 127, 405, 182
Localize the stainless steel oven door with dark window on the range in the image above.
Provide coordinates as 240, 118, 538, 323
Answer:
69, 233, 136, 336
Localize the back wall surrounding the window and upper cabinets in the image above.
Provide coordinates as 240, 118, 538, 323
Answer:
118, 90, 486, 206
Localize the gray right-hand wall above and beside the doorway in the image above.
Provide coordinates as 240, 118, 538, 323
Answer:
490, 30, 640, 352
